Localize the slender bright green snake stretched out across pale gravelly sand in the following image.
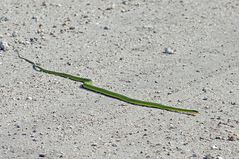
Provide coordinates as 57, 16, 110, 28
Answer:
18, 53, 199, 116
